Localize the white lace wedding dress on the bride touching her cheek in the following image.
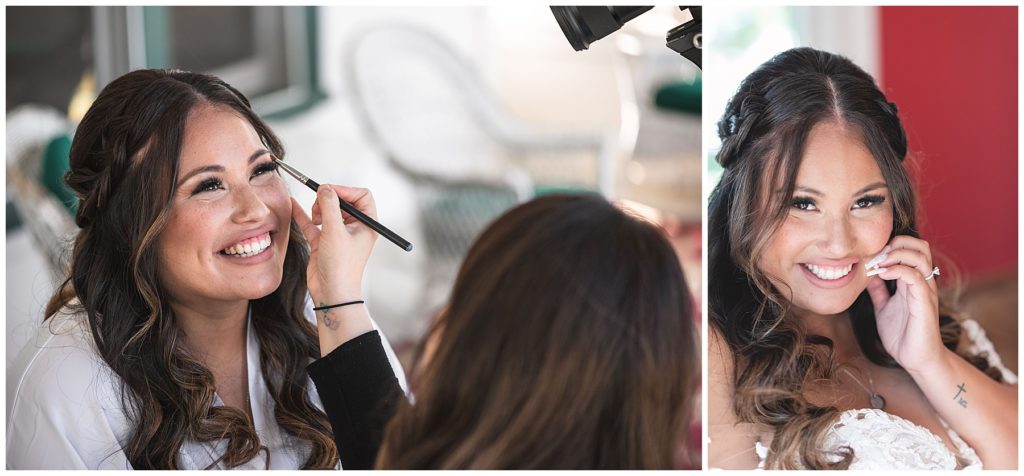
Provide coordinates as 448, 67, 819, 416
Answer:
755, 319, 1017, 470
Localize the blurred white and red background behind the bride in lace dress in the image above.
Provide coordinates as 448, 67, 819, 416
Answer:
703, 5, 1018, 372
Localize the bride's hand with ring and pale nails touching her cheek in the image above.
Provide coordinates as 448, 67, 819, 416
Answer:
867, 235, 946, 372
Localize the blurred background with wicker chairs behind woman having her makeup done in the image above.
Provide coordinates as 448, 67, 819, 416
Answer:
6, 6, 701, 425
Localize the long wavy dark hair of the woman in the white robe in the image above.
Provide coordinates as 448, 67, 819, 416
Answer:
46, 70, 338, 469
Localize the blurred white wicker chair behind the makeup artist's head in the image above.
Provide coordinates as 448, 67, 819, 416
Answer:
345, 25, 616, 309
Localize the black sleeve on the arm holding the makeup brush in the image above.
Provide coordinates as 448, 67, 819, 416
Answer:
306, 331, 404, 470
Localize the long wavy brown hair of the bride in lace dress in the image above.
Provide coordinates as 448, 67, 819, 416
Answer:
708, 48, 1000, 469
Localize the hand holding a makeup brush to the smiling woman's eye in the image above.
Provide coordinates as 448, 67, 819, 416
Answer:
292, 184, 377, 304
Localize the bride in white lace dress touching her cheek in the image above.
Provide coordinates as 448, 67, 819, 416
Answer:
707, 48, 1017, 470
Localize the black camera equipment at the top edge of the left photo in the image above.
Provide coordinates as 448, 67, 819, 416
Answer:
551, 6, 702, 68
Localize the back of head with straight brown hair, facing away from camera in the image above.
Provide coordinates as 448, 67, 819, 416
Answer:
378, 196, 699, 469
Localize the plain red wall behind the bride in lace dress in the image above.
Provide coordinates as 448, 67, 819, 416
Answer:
879, 7, 1018, 277
